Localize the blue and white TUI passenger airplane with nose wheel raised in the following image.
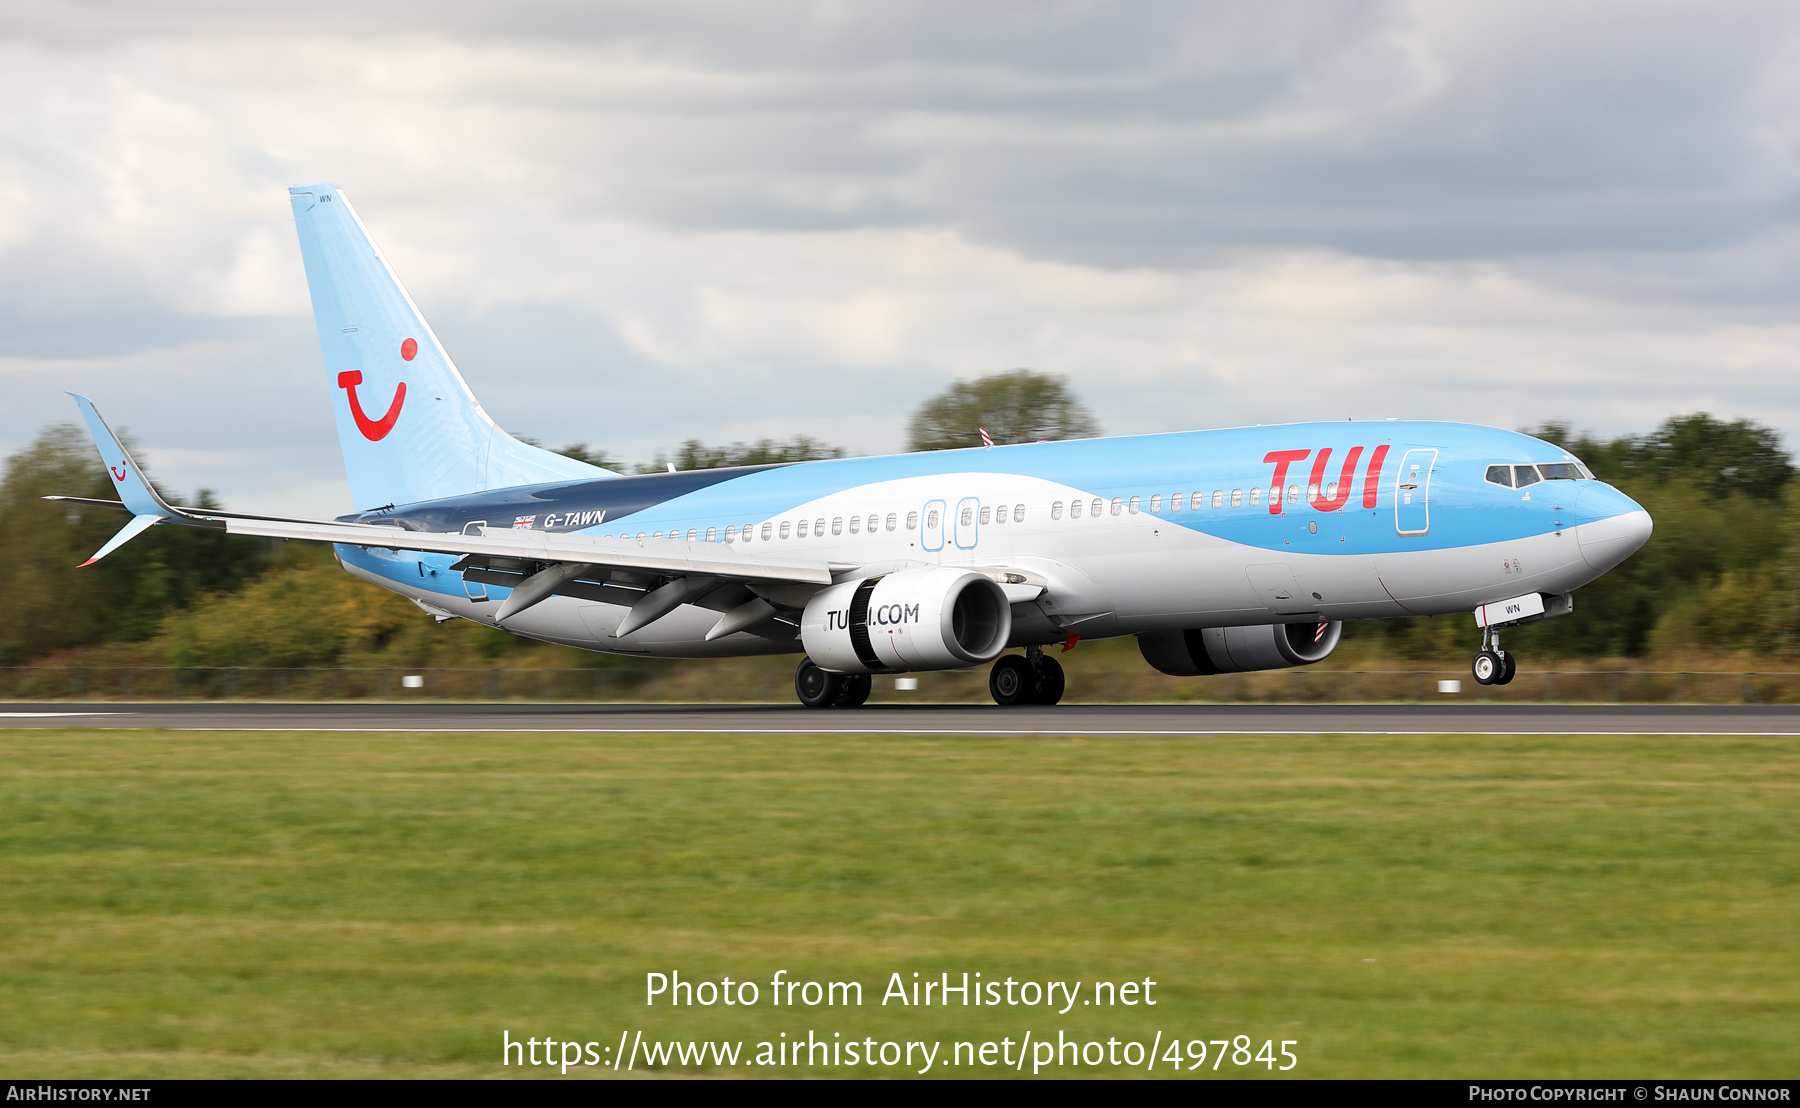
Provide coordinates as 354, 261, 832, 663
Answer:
49, 182, 1652, 709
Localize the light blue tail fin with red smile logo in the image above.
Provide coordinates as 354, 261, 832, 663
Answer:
288, 182, 617, 511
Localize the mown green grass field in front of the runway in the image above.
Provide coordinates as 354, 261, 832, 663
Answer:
0, 730, 1800, 1077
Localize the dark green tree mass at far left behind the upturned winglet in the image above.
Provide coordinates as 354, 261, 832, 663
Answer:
0, 424, 270, 666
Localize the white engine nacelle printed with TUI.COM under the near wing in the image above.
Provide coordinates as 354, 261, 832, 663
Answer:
799, 567, 1012, 673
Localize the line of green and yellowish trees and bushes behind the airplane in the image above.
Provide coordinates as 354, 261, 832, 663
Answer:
0, 371, 1800, 666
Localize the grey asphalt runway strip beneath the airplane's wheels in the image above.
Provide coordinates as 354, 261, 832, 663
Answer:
0, 701, 1800, 736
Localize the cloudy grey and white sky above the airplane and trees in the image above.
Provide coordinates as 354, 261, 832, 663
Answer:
0, 0, 1800, 514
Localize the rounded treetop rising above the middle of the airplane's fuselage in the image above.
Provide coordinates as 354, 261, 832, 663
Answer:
909, 369, 1100, 450
